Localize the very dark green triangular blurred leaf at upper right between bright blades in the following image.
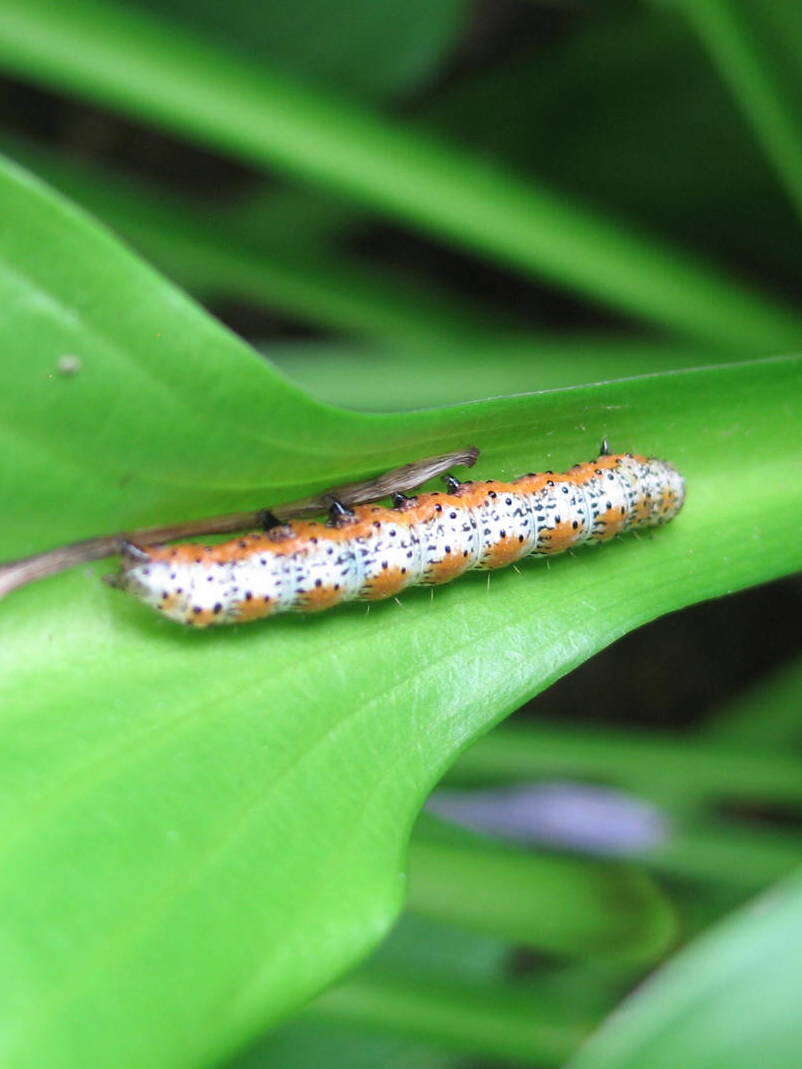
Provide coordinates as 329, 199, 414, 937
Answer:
425, 0, 799, 277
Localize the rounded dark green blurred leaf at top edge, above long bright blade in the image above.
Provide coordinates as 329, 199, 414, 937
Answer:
128, 0, 466, 97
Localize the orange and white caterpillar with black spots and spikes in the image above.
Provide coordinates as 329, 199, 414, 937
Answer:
112, 452, 685, 628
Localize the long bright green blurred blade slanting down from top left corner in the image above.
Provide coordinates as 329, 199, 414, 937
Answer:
0, 0, 802, 353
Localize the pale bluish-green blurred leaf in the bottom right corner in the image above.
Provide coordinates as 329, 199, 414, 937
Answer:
571, 874, 802, 1069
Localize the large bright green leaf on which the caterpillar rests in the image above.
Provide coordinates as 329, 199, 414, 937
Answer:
0, 156, 802, 1069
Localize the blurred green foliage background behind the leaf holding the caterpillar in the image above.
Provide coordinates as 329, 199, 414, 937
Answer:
0, 0, 802, 1069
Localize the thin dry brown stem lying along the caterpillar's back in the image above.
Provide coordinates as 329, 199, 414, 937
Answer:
0, 447, 479, 598
